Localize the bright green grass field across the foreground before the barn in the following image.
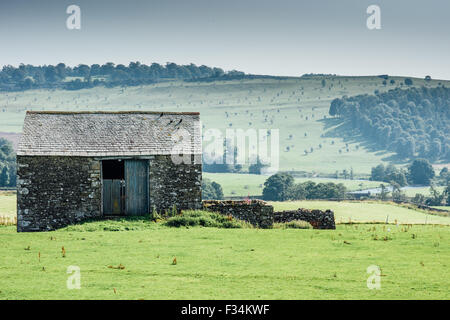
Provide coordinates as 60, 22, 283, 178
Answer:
0, 221, 450, 299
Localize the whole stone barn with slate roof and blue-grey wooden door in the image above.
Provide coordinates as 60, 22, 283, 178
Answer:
17, 112, 202, 232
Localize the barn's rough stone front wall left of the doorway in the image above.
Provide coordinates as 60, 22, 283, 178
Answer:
17, 156, 101, 232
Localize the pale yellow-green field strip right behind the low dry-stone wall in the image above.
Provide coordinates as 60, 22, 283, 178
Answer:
271, 201, 450, 225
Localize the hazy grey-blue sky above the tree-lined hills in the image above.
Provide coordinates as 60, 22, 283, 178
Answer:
0, 0, 450, 79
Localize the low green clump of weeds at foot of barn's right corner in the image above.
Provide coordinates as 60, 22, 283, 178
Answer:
164, 210, 250, 229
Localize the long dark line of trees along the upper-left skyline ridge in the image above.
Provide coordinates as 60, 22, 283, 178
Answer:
0, 62, 245, 91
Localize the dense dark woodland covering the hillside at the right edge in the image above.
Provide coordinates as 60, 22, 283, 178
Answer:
329, 86, 450, 161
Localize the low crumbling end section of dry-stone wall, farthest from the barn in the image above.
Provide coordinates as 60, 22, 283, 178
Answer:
274, 208, 336, 229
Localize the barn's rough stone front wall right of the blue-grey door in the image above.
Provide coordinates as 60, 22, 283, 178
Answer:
149, 155, 202, 212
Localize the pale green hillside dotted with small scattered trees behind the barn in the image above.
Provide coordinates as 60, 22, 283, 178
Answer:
0, 77, 447, 175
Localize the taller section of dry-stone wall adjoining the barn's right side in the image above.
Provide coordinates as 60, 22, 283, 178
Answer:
203, 200, 273, 228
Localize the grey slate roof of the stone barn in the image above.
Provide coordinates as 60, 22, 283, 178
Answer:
17, 111, 202, 156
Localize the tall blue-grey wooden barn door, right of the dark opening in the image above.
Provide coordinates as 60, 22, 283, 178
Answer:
125, 160, 148, 216
